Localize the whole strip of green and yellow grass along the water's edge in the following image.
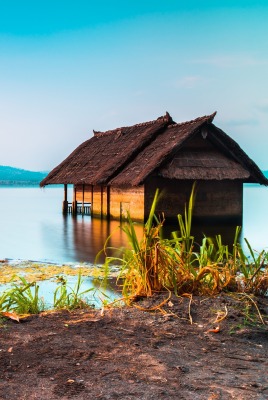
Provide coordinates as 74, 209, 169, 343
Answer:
0, 186, 268, 317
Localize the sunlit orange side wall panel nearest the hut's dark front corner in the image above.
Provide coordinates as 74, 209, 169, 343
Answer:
110, 186, 144, 221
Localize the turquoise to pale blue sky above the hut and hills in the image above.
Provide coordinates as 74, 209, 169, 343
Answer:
0, 0, 268, 171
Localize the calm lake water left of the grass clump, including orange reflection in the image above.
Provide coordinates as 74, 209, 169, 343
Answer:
0, 187, 144, 263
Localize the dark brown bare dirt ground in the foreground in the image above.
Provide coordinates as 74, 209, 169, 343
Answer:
0, 295, 268, 400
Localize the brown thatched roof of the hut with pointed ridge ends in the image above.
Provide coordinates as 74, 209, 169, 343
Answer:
40, 113, 268, 186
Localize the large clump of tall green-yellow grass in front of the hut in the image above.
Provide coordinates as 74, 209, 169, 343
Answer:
102, 185, 268, 302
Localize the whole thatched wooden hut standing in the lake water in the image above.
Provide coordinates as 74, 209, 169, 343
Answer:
40, 113, 268, 224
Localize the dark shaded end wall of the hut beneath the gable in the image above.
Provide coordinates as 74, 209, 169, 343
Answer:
145, 177, 243, 224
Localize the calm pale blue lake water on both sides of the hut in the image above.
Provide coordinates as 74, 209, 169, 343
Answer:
0, 185, 268, 263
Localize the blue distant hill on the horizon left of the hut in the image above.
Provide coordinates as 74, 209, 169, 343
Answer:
0, 165, 48, 185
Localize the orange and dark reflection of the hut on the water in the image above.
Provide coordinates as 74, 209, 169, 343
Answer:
63, 215, 241, 263
